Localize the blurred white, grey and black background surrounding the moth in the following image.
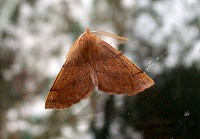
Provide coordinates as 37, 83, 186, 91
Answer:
0, 0, 200, 139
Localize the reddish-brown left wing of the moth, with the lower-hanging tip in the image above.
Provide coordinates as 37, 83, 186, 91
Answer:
45, 60, 94, 109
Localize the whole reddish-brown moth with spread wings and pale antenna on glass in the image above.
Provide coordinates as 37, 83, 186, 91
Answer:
45, 29, 154, 109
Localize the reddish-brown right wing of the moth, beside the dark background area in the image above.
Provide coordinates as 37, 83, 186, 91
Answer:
94, 41, 154, 95
